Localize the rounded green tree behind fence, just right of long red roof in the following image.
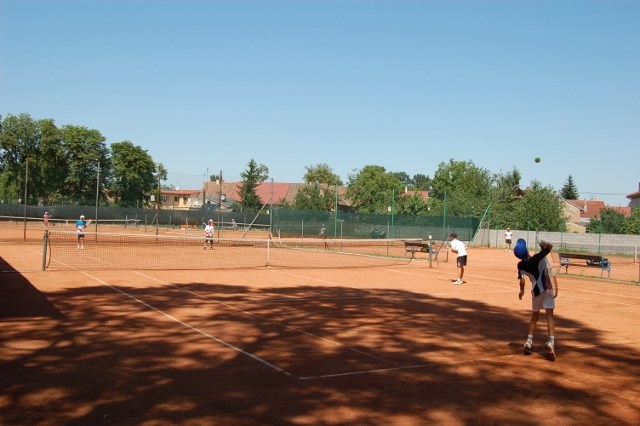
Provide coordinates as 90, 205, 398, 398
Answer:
347, 165, 404, 214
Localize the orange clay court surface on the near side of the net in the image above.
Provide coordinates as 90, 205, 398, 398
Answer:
0, 229, 640, 425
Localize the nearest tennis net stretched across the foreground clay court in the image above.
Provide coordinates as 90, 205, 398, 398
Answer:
42, 230, 416, 270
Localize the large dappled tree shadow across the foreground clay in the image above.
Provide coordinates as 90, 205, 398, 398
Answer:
0, 283, 640, 425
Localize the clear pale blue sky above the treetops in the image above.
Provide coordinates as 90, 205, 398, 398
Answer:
0, 0, 640, 205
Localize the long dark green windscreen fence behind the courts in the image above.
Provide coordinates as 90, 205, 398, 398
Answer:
0, 204, 480, 241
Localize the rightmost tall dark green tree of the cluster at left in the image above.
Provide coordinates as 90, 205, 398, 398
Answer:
110, 141, 156, 207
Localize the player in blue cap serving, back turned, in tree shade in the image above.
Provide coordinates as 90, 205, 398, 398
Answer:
513, 238, 558, 361
